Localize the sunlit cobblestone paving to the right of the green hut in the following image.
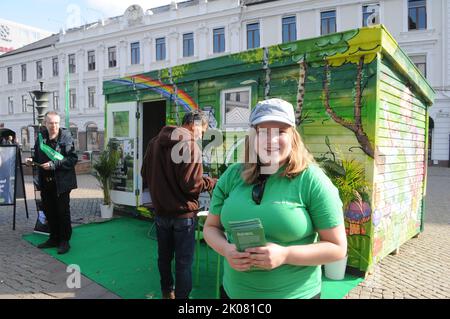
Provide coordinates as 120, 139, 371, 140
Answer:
346, 167, 450, 299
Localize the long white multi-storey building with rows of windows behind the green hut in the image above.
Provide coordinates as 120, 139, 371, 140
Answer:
0, 0, 450, 166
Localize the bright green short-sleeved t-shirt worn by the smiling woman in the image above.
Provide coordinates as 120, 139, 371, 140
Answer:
210, 164, 344, 299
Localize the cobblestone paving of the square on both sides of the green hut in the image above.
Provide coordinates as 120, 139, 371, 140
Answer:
0, 168, 450, 299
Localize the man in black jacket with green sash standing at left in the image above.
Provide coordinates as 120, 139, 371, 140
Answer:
27, 111, 78, 254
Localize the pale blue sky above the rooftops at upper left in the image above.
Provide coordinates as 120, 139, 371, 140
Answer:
0, 0, 180, 32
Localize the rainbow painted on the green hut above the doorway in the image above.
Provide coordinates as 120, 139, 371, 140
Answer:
112, 75, 198, 111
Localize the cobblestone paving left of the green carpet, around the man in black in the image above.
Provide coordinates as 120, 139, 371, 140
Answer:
0, 175, 118, 299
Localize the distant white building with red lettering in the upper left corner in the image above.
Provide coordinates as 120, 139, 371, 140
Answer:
0, 18, 51, 55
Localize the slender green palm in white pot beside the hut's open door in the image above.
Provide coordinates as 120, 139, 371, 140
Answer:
93, 144, 120, 218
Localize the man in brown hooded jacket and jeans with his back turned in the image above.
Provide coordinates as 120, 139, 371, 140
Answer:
141, 111, 216, 299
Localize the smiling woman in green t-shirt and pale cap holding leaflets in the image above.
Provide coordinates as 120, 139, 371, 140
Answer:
204, 99, 347, 299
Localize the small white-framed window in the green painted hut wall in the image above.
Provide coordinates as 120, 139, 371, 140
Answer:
221, 87, 251, 127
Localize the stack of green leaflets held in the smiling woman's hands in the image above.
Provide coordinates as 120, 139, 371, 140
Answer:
228, 218, 266, 252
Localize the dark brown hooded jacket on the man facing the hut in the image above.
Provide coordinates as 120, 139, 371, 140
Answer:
141, 126, 216, 218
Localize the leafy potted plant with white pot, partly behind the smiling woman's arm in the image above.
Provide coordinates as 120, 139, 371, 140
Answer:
317, 138, 371, 280
